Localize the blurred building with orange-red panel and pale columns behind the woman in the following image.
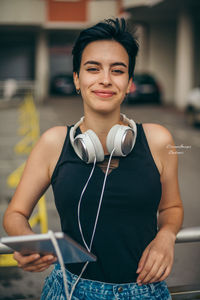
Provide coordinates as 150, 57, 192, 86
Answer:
0, 0, 200, 109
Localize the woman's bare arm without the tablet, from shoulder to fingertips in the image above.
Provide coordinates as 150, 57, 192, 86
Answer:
137, 124, 183, 284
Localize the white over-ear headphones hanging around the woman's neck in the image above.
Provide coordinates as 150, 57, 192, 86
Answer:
70, 114, 137, 164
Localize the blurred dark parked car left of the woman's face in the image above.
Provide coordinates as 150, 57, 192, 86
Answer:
50, 73, 76, 95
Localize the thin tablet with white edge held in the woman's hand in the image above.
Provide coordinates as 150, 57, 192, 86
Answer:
0, 232, 96, 264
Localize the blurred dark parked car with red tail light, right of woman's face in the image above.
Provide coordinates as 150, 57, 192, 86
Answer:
125, 73, 161, 104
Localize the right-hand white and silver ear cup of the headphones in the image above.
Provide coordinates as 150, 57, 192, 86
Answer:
106, 124, 136, 156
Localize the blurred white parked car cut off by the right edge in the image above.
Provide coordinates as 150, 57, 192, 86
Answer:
185, 87, 200, 126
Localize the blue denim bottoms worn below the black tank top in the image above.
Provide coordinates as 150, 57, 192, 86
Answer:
40, 264, 172, 300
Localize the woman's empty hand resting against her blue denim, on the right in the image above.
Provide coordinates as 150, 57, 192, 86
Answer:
136, 230, 175, 285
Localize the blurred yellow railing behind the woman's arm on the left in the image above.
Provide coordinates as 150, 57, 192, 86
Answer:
0, 95, 48, 267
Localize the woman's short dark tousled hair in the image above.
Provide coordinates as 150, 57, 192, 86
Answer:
72, 18, 138, 79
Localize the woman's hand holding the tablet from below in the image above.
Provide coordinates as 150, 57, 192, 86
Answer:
13, 251, 57, 272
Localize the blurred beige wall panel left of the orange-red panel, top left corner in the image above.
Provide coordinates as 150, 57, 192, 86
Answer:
0, 0, 46, 25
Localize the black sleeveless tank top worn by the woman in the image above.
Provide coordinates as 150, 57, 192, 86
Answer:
51, 123, 161, 283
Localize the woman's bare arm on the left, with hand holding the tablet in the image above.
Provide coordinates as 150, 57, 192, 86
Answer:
3, 127, 67, 271
